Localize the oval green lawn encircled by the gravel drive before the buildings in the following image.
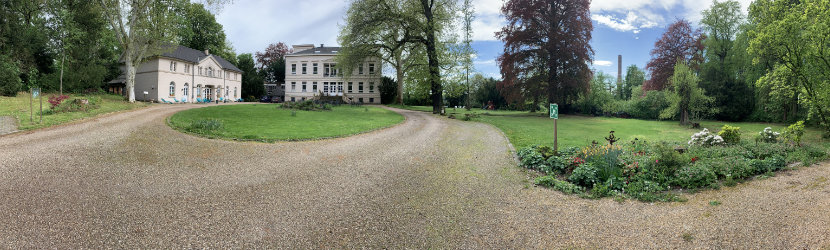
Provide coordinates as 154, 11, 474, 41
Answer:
169, 104, 404, 141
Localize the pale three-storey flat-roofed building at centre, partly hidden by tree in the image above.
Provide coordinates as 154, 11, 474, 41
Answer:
285, 44, 382, 104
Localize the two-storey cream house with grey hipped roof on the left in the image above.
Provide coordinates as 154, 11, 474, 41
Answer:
109, 46, 242, 103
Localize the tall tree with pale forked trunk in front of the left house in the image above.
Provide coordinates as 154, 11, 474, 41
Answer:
100, 0, 180, 102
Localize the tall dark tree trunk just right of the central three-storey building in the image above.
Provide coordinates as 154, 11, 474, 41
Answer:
421, 0, 444, 114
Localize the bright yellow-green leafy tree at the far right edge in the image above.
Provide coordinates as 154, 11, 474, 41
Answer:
748, 0, 830, 133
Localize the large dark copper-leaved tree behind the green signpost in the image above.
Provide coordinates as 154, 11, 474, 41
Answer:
496, 0, 594, 111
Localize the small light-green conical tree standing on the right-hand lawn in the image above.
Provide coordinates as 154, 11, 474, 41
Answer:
660, 60, 717, 125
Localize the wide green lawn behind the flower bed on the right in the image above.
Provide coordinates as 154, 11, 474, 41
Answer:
396, 106, 830, 149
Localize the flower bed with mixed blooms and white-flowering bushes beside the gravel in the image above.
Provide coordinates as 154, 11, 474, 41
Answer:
518, 124, 827, 202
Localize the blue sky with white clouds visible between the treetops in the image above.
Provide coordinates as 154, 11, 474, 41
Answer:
217, 0, 751, 78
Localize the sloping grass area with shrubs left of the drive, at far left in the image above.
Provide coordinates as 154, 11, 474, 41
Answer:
0, 92, 149, 130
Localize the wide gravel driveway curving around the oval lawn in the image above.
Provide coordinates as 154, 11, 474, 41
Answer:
0, 105, 830, 248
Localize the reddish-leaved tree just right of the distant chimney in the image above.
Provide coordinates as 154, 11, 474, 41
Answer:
643, 19, 704, 90
